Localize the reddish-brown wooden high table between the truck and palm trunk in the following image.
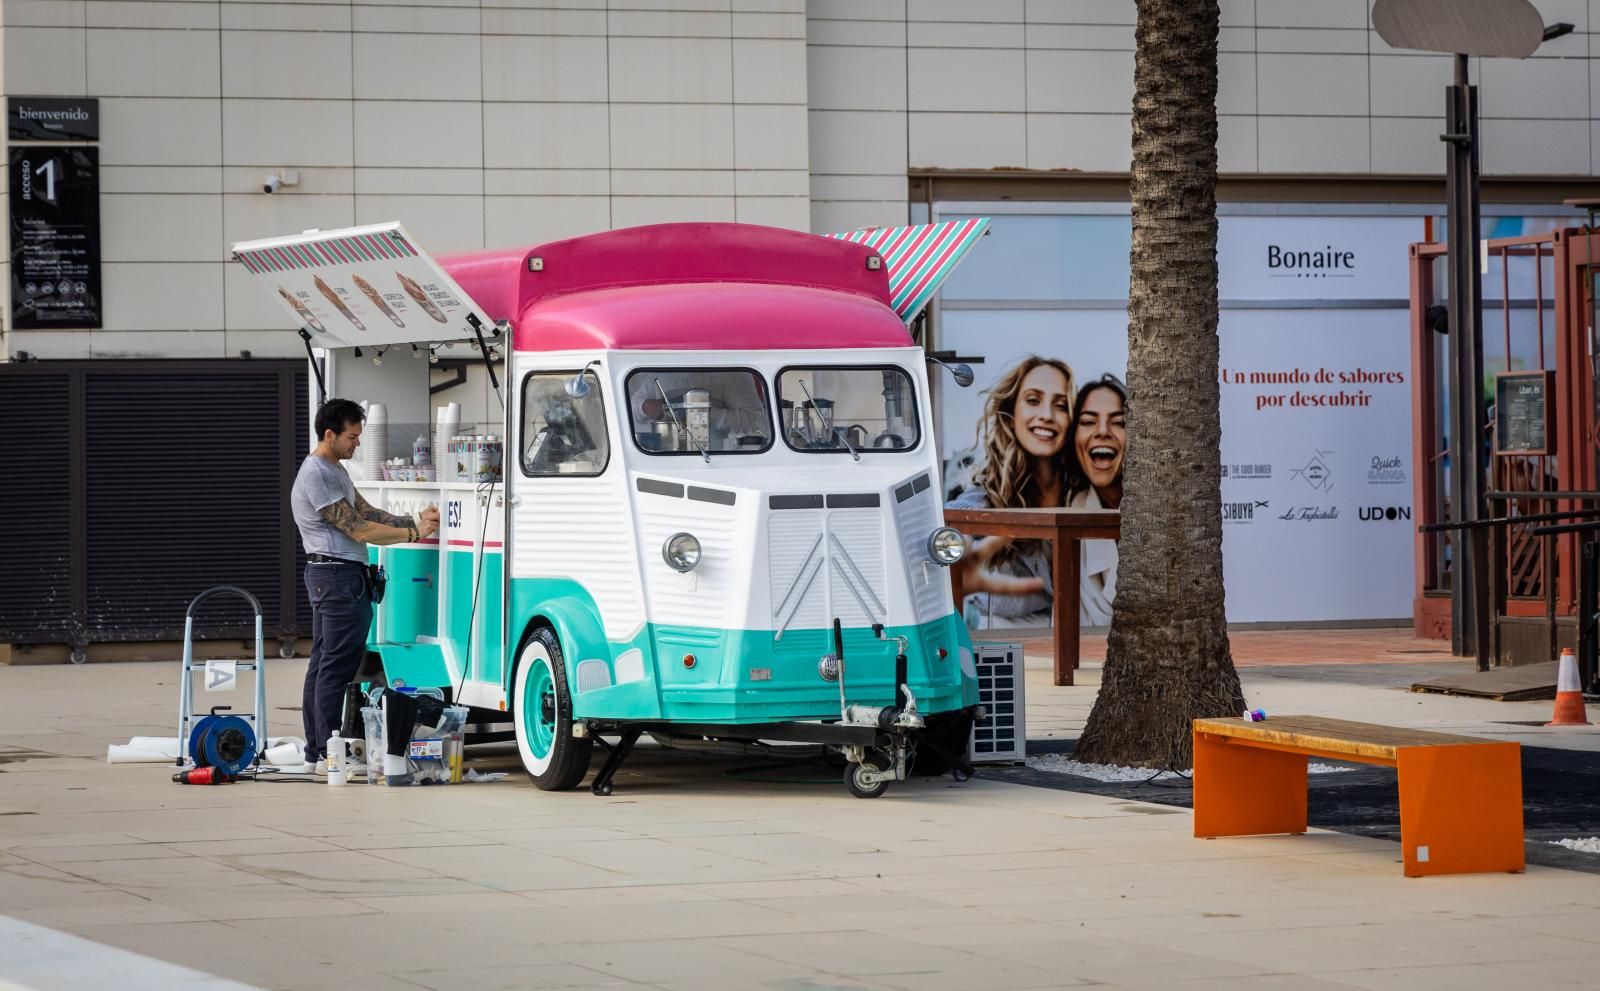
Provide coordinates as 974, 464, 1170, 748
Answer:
944, 509, 1122, 685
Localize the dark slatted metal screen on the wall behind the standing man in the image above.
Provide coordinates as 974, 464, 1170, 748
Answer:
0, 360, 310, 647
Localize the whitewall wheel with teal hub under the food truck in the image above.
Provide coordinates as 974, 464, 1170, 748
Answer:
514, 626, 594, 791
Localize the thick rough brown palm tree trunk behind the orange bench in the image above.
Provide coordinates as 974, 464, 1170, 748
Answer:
1077, 0, 1243, 767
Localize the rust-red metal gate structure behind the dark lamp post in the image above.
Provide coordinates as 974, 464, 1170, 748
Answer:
1411, 227, 1600, 664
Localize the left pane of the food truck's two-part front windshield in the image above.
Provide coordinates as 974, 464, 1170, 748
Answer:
627, 368, 773, 456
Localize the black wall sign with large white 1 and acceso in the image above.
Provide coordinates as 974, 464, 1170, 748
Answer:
10, 146, 101, 330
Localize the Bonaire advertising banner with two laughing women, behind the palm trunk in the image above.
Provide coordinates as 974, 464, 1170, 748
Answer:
938, 215, 1422, 626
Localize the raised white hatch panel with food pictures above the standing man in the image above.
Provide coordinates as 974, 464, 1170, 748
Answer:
234, 223, 491, 347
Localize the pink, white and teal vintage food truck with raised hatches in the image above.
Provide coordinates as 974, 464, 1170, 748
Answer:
234, 219, 987, 797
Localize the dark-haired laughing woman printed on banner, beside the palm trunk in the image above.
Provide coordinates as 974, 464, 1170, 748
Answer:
1067, 375, 1128, 626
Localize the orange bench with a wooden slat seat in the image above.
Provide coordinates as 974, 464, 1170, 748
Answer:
1194, 716, 1525, 877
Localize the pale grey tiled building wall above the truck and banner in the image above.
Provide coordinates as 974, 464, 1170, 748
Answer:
0, 0, 1600, 359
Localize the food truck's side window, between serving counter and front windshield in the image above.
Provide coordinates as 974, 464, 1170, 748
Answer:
520, 368, 611, 477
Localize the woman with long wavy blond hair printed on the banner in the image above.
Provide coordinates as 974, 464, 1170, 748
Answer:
949, 355, 1077, 626
